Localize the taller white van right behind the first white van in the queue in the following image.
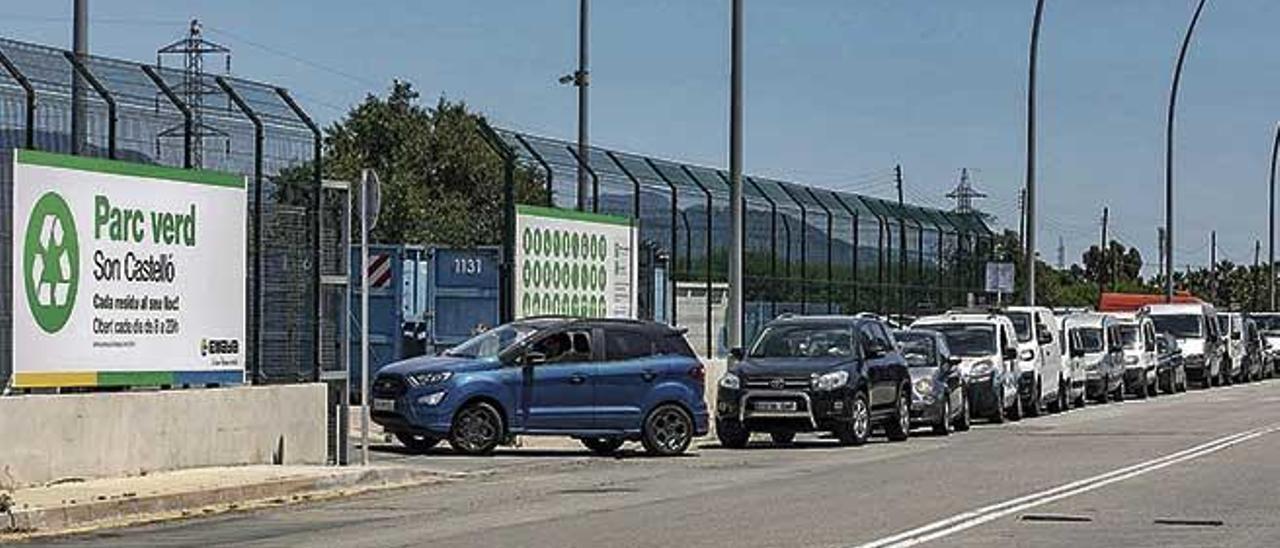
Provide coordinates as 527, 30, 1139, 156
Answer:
1005, 306, 1068, 416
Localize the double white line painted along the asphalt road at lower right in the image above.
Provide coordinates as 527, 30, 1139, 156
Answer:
858, 424, 1280, 548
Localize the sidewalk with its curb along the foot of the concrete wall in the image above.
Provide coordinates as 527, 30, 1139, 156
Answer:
0, 466, 454, 542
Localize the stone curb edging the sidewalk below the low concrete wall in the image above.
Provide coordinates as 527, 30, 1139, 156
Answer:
0, 467, 455, 542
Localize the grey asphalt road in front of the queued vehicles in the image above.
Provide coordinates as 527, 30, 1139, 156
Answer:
24, 382, 1280, 548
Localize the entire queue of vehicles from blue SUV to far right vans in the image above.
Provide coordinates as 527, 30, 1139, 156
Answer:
370, 305, 1280, 456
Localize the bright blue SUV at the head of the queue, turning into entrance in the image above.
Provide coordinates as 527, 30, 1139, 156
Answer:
371, 318, 708, 456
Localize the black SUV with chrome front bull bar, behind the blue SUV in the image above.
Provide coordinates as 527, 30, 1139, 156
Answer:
716, 316, 911, 448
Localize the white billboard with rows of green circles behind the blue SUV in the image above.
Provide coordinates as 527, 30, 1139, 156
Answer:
515, 205, 639, 318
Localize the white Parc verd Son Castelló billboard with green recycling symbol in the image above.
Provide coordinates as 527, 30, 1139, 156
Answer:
12, 150, 246, 388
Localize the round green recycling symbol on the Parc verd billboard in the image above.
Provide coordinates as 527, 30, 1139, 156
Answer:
22, 192, 79, 333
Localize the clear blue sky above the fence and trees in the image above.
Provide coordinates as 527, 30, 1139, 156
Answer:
0, 0, 1280, 273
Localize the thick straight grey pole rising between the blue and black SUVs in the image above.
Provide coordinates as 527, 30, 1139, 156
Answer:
728, 0, 745, 348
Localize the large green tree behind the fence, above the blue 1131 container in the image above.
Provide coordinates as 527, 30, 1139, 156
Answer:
275, 81, 550, 247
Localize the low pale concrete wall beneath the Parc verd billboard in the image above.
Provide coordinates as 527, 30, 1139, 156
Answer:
0, 384, 326, 487
